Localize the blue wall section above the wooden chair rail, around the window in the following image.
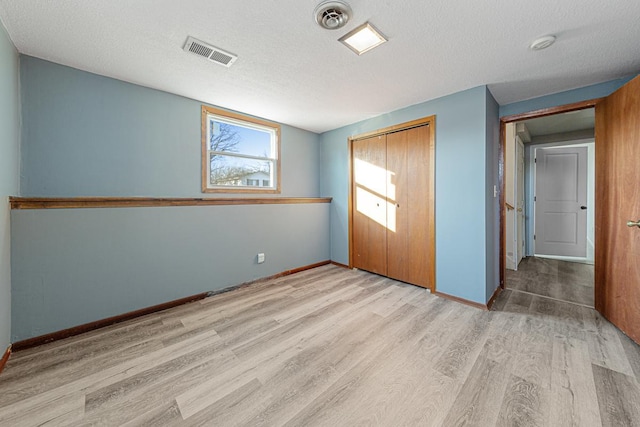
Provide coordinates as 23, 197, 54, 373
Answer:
20, 55, 319, 197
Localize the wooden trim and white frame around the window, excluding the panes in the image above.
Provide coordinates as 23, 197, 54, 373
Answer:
200, 105, 282, 194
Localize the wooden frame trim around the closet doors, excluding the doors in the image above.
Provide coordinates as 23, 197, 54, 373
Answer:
347, 116, 436, 294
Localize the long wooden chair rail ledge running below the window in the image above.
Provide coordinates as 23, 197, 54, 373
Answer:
9, 197, 332, 209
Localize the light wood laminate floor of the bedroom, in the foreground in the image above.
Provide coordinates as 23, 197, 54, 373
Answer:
0, 265, 640, 427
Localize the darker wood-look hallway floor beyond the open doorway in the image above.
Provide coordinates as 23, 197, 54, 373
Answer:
505, 257, 594, 307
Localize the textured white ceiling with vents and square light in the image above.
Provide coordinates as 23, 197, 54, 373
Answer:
0, 0, 640, 132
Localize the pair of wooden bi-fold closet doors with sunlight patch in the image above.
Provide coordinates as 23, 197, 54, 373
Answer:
351, 120, 434, 290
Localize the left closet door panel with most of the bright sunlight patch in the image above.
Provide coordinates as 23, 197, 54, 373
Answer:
351, 135, 388, 275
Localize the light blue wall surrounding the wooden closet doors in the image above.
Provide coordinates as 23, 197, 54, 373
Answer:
320, 86, 498, 304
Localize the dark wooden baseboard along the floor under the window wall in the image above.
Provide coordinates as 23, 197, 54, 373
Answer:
11, 260, 330, 352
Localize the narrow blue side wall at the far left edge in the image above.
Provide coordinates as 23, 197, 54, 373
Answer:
0, 22, 20, 355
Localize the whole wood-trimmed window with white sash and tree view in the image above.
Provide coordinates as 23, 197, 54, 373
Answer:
202, 106, 280, 193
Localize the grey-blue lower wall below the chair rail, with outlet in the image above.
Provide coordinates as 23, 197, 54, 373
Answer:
11, 203, 329, 342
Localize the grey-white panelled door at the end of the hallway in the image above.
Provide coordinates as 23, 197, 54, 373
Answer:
534, 147, 588, 257
